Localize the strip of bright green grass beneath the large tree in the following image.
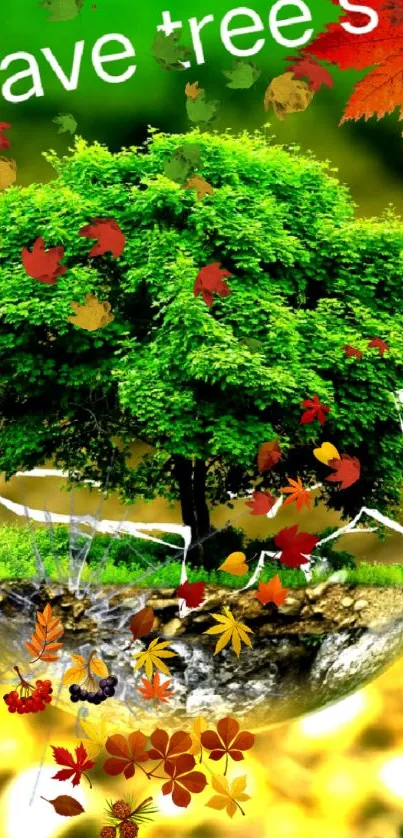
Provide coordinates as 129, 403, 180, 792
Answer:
0, 526, 403, 589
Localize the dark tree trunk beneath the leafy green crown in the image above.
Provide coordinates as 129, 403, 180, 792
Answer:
175, 456, 210, 565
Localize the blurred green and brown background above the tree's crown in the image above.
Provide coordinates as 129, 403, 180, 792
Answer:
0, 0, 403, 215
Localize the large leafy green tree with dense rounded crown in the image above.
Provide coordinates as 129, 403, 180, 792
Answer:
0, 131, 403, 564
